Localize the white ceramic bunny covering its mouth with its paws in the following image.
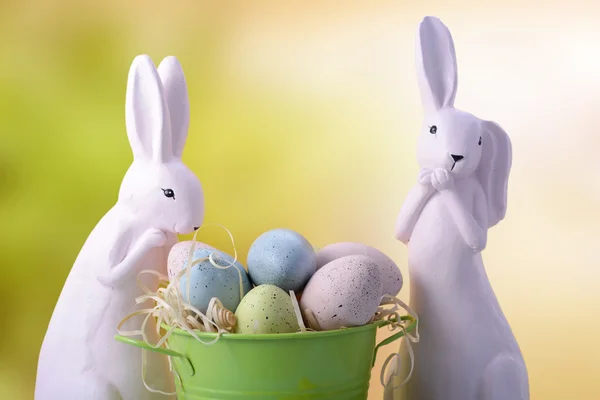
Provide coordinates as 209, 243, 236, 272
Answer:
396, 17, 529, 400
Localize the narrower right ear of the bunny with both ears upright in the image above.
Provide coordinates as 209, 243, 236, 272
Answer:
158, 56, 190, 158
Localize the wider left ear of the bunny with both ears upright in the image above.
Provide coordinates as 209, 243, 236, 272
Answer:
125, 55, 173, 162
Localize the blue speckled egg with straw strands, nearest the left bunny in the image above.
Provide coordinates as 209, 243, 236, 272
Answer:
179, 249, 252, 313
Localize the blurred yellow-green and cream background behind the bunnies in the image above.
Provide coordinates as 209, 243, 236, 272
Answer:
0, 0, 600, 400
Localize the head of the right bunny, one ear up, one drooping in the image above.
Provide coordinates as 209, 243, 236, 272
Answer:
416, 17, 512, 227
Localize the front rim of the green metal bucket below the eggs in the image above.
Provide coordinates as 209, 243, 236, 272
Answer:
161, 321, 386, 341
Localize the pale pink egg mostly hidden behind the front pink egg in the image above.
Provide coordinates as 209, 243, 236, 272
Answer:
317, 242, 403, 296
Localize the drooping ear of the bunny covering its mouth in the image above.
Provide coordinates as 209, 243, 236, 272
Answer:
477, 121, 512, 228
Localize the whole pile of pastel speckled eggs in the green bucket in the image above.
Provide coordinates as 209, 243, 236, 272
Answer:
168, 229, 403, 334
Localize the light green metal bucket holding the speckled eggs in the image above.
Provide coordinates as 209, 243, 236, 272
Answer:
115, 316, 416, 400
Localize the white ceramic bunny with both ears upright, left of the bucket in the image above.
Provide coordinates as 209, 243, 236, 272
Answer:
35, 55, 204, 400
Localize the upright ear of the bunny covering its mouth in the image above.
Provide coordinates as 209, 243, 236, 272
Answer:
416, 17, 458, 112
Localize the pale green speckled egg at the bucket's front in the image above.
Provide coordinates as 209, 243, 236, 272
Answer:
235, 285, 300, 334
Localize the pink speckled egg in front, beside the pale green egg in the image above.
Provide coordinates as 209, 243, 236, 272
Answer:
300, 255, 381, 330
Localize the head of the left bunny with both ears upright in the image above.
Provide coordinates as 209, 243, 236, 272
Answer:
119, 55, 204, 234
